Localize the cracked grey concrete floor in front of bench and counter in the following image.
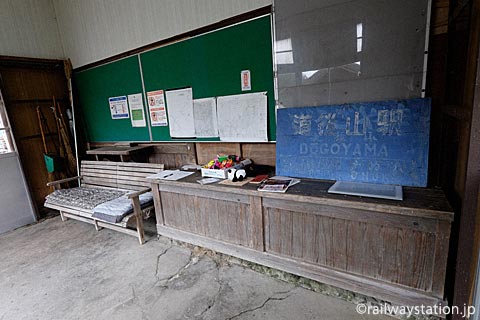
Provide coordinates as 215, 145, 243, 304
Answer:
0, 217, 392, 320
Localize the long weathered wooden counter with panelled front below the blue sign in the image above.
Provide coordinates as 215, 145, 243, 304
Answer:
151, 173, 453, 305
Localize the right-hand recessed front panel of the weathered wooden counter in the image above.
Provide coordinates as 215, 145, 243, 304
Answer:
264, 208, 436, 292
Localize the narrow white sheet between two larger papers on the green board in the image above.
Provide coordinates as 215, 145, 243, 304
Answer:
193, 98, 218, 138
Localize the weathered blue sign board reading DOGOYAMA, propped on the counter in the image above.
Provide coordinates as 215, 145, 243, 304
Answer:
276, 99, 431, 187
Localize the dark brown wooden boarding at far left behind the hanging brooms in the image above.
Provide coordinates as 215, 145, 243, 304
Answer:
0, 56, 70, 217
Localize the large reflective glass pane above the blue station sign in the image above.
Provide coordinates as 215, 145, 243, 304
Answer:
274, 0, 428, 107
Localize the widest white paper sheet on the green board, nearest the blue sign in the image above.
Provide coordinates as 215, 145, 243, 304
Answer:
217, 92, 268, 142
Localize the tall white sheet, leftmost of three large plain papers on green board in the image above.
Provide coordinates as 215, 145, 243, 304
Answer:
165, 88, 195, 138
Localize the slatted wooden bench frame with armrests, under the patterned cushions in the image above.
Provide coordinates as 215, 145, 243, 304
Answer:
45, 161, 164, 244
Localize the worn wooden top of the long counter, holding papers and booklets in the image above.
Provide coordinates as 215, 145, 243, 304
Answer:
150, 173, 453, 221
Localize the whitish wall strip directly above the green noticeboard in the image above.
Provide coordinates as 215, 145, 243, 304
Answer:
52, 0, 272, 67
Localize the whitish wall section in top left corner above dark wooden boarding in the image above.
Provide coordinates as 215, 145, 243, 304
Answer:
0, 0, 64, 59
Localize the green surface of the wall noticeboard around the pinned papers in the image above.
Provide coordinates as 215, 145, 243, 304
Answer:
74, 15, 276, 142
